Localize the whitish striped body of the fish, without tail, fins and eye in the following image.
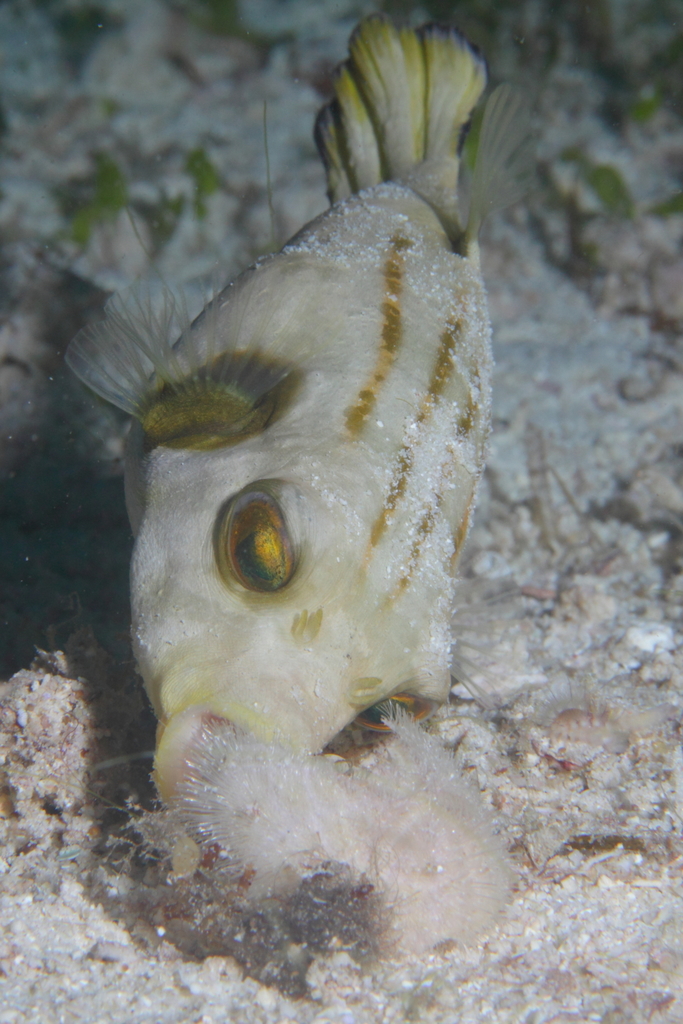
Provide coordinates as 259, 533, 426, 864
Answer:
127, 184, 490, 782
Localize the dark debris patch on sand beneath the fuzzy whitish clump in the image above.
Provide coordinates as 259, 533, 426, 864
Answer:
91, 843, 390, 998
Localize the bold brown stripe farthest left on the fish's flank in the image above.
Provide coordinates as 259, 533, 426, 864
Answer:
346, 234, 413, 437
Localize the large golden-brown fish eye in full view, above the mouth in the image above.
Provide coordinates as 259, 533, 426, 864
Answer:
218, 487, 296, 594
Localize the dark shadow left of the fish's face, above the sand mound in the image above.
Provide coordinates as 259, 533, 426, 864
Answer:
0, 403, 132, 675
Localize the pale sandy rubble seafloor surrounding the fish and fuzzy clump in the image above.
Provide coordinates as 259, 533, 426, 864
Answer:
0, 0, 683, 1024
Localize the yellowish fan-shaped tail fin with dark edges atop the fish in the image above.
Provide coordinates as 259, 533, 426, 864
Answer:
315, 16, 487, 203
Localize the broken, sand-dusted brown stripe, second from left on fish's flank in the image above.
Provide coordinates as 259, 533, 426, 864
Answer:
369, 321, 466, 555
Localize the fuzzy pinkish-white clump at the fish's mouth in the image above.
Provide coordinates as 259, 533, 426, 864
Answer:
178, 718, 511, 953
